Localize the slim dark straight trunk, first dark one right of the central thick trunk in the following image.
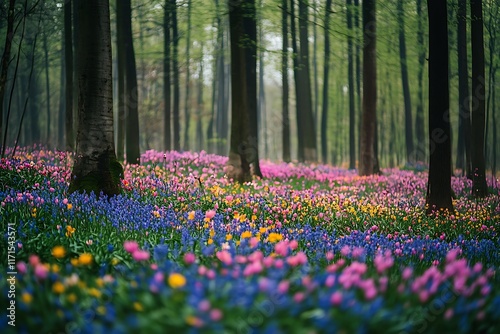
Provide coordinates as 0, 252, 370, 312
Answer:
281, 0, 291, 162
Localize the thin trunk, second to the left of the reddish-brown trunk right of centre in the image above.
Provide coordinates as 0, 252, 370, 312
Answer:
321, 0, 332, 163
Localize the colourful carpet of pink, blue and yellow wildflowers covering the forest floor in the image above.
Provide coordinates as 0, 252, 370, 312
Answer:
0, 147, 500, 333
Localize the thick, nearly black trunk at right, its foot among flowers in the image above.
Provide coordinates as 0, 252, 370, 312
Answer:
426, 0, 453, 214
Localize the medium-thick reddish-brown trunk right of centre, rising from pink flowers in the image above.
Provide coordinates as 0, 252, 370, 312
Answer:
359, 0, 378, 176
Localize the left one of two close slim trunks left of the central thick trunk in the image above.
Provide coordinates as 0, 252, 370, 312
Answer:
163, 0, 172, 151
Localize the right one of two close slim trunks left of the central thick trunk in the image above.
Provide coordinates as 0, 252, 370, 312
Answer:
170, 0, 181, 151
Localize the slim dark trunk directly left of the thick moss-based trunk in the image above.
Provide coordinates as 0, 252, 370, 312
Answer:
64, 1, 75, 151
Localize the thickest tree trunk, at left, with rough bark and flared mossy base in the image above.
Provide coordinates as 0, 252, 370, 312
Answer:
69, 0, 123, 196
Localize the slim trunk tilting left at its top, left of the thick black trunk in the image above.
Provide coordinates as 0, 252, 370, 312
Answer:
398, 0, 415, 162
